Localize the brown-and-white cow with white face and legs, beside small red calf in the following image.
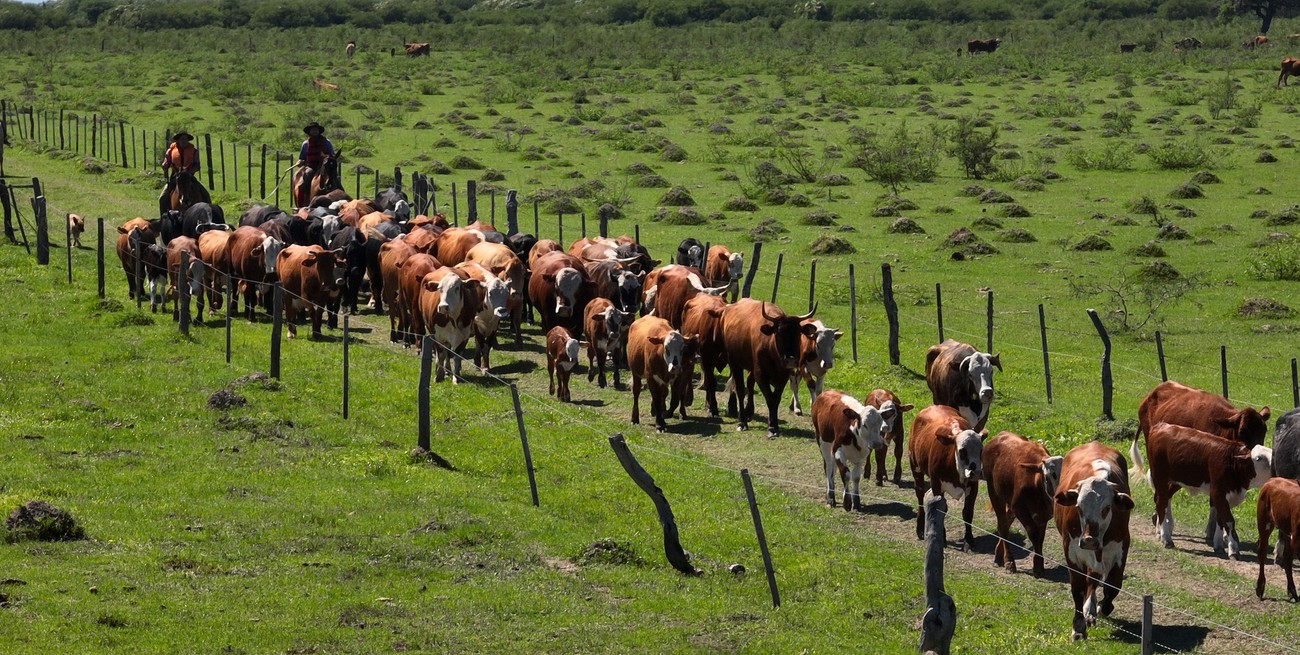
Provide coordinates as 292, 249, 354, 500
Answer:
811, 389, 898, 512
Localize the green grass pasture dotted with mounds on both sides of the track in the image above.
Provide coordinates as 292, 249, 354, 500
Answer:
0, 16, 1297, 652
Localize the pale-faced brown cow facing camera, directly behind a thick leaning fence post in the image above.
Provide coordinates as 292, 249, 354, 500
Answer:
420, 266, 484, 385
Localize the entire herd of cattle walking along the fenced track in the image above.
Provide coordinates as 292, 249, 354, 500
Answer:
104, 190, 1300, 639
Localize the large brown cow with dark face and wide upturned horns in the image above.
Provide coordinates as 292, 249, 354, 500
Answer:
722, 298, 816, 437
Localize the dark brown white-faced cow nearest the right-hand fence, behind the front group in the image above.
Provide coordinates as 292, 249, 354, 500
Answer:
926, 339, 1002, 430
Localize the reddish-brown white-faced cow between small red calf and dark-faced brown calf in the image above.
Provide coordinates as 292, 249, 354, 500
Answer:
907, 404, 988, 551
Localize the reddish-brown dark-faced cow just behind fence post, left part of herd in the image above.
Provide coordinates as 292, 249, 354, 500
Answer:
276, 246, 347, 339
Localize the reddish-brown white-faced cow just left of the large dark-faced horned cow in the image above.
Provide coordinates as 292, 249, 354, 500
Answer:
628, 316, 697, 431
